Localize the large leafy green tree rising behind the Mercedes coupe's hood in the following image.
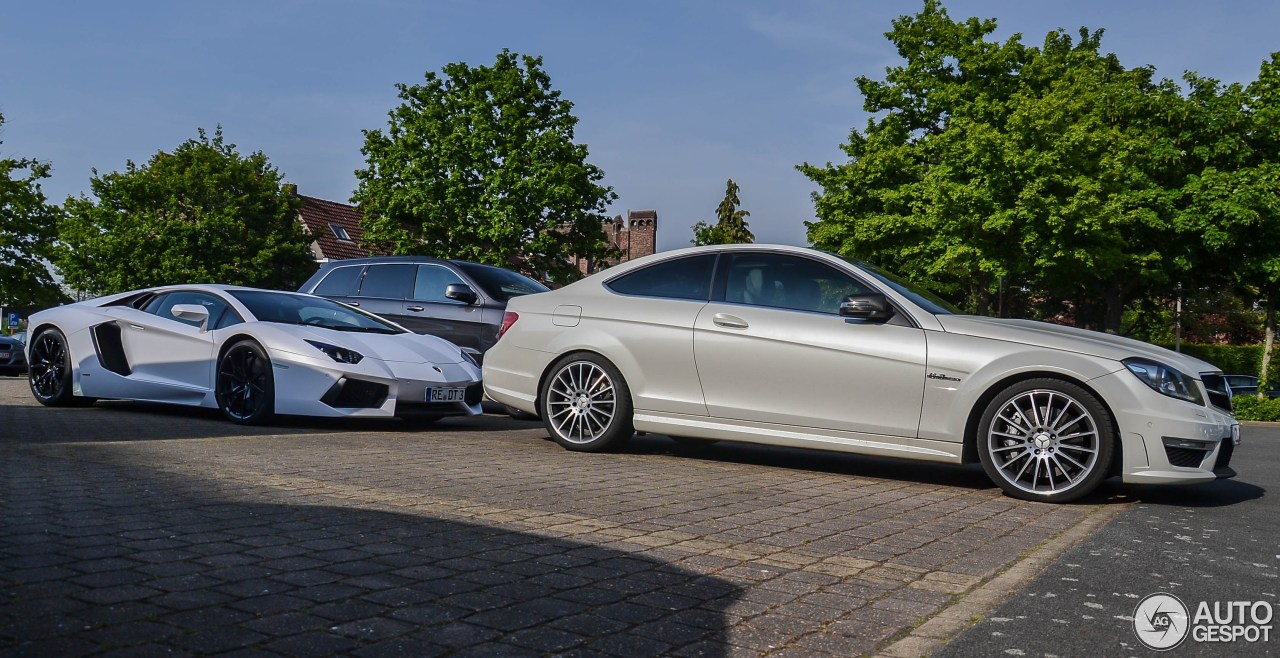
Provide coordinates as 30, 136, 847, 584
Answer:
800, 0, 1180, 330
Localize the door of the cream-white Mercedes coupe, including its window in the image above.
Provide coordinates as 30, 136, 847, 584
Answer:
694, 251, 925, 438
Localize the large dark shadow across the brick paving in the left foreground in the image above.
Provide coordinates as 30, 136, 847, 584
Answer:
0, 447, 742, 655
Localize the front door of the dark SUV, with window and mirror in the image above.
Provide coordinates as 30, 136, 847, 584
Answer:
399, 264, 488, 351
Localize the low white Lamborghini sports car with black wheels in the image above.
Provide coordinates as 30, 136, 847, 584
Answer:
27, 285, 484, 424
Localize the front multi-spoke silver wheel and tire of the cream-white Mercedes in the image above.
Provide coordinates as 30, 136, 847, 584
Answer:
975, 379, 1116, 503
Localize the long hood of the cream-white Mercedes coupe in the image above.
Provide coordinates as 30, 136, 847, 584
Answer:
936, 315, 1220, 376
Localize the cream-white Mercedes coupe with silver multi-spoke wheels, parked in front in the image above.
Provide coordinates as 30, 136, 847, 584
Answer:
484, 245, 1240, 502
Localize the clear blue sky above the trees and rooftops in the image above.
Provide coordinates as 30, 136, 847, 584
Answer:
0, 0, 1280, 250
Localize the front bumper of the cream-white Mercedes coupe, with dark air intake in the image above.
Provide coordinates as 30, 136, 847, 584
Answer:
1091, 371, 1240, 484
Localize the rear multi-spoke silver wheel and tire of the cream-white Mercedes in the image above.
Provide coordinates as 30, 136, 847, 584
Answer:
538, 353, 635, 452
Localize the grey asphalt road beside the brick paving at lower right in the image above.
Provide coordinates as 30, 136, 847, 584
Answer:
936, 425, 1280, 658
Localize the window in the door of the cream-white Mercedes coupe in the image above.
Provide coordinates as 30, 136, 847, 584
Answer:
724, 253, 872, 314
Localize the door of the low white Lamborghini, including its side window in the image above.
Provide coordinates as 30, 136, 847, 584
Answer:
116, 291, 225, 402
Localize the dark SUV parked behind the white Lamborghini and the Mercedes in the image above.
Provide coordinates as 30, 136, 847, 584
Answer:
298, 256, 548, 361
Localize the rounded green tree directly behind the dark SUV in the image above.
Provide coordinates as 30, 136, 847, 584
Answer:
352, 50, 617, 282
